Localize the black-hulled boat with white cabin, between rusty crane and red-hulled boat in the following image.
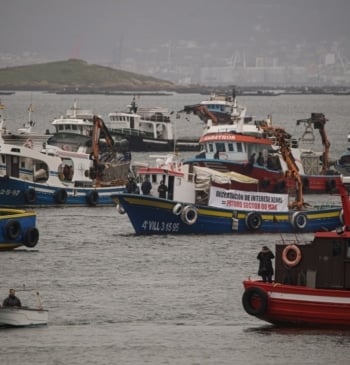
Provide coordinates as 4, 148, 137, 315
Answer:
106, 96, 199, 152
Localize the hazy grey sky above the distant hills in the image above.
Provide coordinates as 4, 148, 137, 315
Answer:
0, 0, 350, 62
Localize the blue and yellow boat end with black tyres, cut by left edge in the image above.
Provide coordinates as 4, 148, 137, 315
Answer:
0, 208, 39, 250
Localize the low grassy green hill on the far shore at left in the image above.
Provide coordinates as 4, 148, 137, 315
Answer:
0, 59, 174, 91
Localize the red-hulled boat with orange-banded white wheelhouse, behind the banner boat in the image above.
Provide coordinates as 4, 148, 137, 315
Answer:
187, 105, 340, 193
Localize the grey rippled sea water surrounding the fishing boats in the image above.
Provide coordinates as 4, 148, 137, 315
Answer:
0, 92, 350, 365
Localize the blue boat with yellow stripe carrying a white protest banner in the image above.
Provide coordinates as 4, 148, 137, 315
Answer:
116, 153, 341, 235
